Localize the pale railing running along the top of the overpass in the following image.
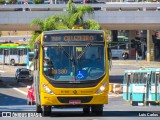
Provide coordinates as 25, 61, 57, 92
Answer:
0, 2, 160, 12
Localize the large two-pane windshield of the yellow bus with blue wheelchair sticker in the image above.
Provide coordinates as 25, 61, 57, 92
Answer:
43, 44, 105, 81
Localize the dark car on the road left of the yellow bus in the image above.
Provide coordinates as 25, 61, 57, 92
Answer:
15, 68, 33, 82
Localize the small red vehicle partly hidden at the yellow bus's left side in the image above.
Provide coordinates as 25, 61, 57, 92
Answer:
27, 84, 35, 105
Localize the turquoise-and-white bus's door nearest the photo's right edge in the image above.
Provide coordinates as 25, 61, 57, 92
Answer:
155, 72, 160, 102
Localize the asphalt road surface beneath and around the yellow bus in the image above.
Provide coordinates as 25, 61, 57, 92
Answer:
0, 63, 160, 120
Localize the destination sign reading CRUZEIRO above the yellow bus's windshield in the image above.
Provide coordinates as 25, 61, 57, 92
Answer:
44, 33, 103, 42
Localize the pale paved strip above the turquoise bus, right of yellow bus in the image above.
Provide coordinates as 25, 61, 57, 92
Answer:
112, 60, 160, 68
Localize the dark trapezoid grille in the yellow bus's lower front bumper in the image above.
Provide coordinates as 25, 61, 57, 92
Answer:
57, 96, 93, 103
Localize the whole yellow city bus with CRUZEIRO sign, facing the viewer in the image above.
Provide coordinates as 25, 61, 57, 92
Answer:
34, 30, 109, 116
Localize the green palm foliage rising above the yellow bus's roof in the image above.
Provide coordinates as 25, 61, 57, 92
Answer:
30, 0, 101, 48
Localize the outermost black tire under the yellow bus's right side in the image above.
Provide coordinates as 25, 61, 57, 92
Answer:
91, 105, 103, 115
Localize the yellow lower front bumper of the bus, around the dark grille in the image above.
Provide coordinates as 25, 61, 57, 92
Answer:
41, 94, 108, 106
